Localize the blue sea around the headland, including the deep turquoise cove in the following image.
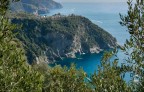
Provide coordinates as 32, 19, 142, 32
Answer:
47, 2, 130, 80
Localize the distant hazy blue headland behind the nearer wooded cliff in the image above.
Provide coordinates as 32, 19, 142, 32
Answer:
11, 0, 62, 14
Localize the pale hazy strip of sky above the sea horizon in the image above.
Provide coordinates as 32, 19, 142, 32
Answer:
54, 0, 127, 2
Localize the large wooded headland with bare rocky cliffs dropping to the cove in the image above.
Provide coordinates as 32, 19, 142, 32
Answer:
13, 15, 117, 62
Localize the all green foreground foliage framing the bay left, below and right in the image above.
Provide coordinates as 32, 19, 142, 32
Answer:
0, 0, 144, 92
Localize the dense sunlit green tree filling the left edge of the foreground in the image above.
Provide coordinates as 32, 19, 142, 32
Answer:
0, 0, 43, 92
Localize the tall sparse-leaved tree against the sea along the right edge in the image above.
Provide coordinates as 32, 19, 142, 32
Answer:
120, 0, 144, 92
